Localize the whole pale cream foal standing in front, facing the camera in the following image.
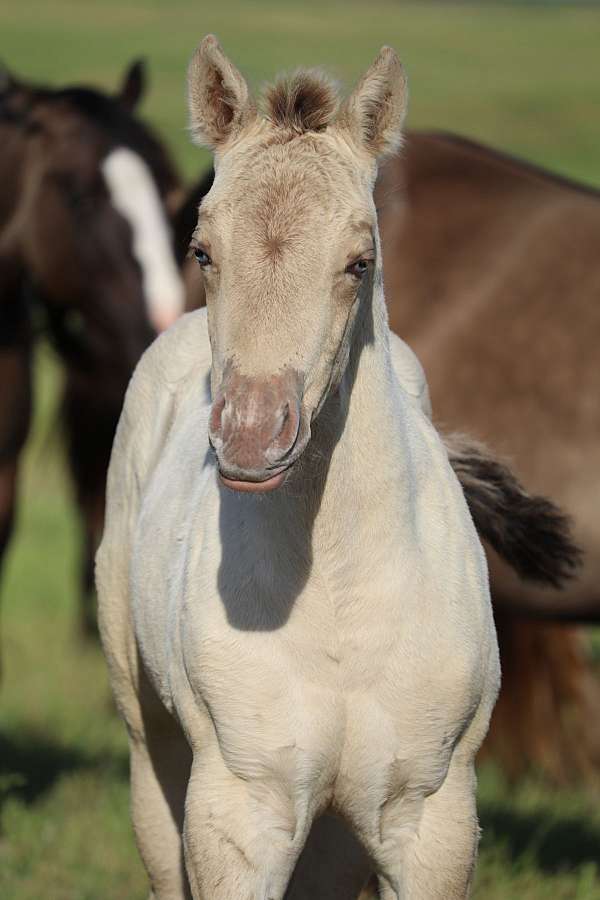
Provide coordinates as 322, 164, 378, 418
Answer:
98, 38, 499, 900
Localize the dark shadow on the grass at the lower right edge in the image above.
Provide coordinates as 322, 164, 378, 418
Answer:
479, 803, 600, 873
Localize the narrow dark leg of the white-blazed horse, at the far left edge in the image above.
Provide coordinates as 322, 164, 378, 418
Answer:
0, 342, 31, 668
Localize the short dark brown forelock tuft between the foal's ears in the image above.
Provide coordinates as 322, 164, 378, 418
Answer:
264, 69, 339, 134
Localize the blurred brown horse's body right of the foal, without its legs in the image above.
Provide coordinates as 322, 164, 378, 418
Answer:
376, 132, 600, 621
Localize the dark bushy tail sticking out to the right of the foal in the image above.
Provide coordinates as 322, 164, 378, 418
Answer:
443, 434, 581, 588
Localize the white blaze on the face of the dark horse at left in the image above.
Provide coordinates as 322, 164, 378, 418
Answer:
102, 147, 184, 331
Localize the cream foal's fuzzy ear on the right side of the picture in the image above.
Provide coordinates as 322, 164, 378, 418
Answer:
338, 47, 408, 157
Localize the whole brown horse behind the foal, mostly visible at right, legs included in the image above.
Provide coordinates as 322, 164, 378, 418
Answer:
176, 133, 600, 779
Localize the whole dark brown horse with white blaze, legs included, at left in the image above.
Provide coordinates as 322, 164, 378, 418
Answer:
0, 63, 183, 627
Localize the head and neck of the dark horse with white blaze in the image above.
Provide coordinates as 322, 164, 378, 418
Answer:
0, 63, 183, 370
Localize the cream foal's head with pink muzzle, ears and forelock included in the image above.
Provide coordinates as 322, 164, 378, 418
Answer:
189, 36, 406, 490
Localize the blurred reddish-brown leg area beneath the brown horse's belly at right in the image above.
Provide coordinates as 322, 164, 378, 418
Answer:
481, 614, 600, 782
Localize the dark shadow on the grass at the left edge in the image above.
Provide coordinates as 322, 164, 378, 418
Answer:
0, 731, 129, 809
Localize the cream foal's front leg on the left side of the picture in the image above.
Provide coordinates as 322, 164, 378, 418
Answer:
183, 750, 305, 900
